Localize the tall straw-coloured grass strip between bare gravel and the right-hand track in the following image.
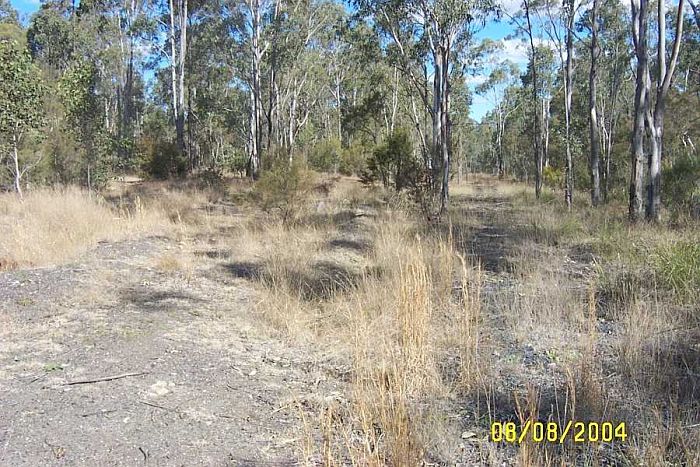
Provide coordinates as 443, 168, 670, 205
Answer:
223, 180, 481, 466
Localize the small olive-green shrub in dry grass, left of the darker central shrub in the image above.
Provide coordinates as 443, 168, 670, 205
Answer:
254, 158, 316, 224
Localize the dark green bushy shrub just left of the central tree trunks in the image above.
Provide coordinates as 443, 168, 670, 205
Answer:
363, 129, 419, 191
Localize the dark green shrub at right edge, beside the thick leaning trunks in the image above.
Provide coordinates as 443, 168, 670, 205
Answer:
662, 154, 700, 217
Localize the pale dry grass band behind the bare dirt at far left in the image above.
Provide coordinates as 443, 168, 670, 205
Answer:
0, 178, 230, 269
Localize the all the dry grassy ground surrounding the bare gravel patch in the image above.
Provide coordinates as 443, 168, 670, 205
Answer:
0, 177, 700, 466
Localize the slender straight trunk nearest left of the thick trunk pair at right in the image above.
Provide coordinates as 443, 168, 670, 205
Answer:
588, 0, 600, 206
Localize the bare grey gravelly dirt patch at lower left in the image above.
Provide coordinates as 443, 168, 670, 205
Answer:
0, 232, 342, 466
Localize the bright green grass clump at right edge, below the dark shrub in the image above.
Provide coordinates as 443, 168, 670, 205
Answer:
650, 241, 700, 302
